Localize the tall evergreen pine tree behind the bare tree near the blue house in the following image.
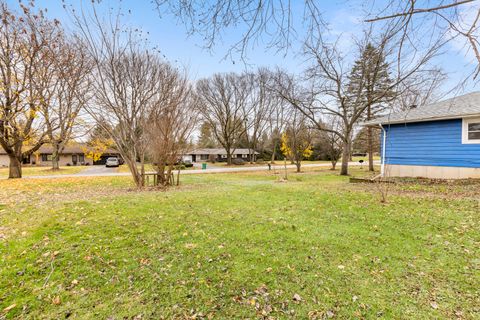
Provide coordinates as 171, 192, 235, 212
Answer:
348, 43, 395, 171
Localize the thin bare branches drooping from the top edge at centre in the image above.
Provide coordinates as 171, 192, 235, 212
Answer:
155, 0, 326, 60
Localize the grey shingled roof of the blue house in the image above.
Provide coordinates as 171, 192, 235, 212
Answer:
363, 92, 480, 126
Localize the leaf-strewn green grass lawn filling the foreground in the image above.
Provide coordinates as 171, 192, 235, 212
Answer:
0, 168, 480, 319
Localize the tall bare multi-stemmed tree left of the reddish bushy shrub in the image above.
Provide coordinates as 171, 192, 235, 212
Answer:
73, 4, 162, 187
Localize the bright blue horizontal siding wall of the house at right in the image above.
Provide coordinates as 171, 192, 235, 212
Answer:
381, 119, 480, 168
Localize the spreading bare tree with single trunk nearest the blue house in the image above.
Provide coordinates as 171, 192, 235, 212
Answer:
277, 30, 440, 175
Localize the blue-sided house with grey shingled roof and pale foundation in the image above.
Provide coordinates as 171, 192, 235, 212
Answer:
365, 92, 480, 179
